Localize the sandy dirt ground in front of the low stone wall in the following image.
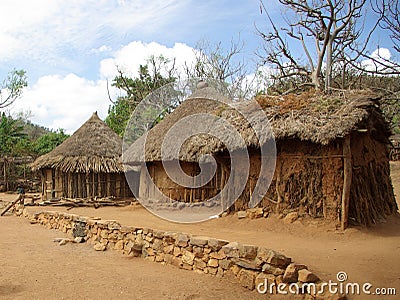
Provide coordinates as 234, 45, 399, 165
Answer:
0, 216, 258, 299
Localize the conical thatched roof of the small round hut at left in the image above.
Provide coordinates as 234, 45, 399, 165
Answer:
31, 112, 123, 173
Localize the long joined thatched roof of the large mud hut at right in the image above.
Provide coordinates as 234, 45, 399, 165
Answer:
124, 90, 390, 164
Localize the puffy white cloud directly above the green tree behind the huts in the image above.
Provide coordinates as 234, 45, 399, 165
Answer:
100, 41, 195, 79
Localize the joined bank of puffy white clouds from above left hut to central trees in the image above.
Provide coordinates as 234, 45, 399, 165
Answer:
11, 42, 198, 133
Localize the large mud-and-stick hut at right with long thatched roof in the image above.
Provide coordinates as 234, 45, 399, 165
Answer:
125, 88, 397, 227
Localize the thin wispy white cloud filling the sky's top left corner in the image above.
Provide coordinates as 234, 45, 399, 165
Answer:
0, 0, 186, 64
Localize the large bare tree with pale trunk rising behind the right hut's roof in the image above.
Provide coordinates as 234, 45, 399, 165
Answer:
257, 0, 366, 91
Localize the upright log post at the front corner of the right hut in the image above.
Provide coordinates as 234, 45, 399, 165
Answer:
341, 135, 353, 230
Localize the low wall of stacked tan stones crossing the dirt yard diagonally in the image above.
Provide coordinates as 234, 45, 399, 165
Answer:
14, 205, 340, 299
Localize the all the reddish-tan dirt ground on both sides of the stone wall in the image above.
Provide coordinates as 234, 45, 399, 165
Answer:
0, 162, 400, 299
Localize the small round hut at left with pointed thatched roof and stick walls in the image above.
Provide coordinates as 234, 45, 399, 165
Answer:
31, 112, 135, 199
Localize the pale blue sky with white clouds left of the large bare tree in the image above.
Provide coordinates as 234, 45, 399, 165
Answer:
0, 0, 394, 133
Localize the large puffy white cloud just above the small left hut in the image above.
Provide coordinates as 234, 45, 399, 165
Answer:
12, 74, 110, 133
